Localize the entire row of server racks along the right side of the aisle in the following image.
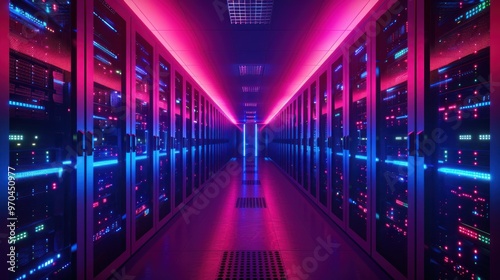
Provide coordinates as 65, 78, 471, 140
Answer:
262, 0, 500, 279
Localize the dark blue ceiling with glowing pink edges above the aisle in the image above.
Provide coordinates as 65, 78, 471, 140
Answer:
125, 0, 377, 123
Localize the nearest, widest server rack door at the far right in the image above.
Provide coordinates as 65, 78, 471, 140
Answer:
419, 0, 492, 279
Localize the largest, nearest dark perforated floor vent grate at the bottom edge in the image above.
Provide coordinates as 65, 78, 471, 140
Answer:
216, 251, 286, 280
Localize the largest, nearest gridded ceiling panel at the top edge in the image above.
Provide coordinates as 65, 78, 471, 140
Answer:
227, 0, 274, 24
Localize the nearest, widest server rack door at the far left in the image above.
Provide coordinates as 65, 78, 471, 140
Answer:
8, 0, 76, 279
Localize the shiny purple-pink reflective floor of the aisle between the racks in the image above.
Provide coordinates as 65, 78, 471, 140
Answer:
121, 159, 389, 280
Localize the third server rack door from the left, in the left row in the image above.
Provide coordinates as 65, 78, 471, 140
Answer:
132, 33, 155, 244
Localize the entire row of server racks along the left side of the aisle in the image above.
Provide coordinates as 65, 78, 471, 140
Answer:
0, 0, 237, 280
